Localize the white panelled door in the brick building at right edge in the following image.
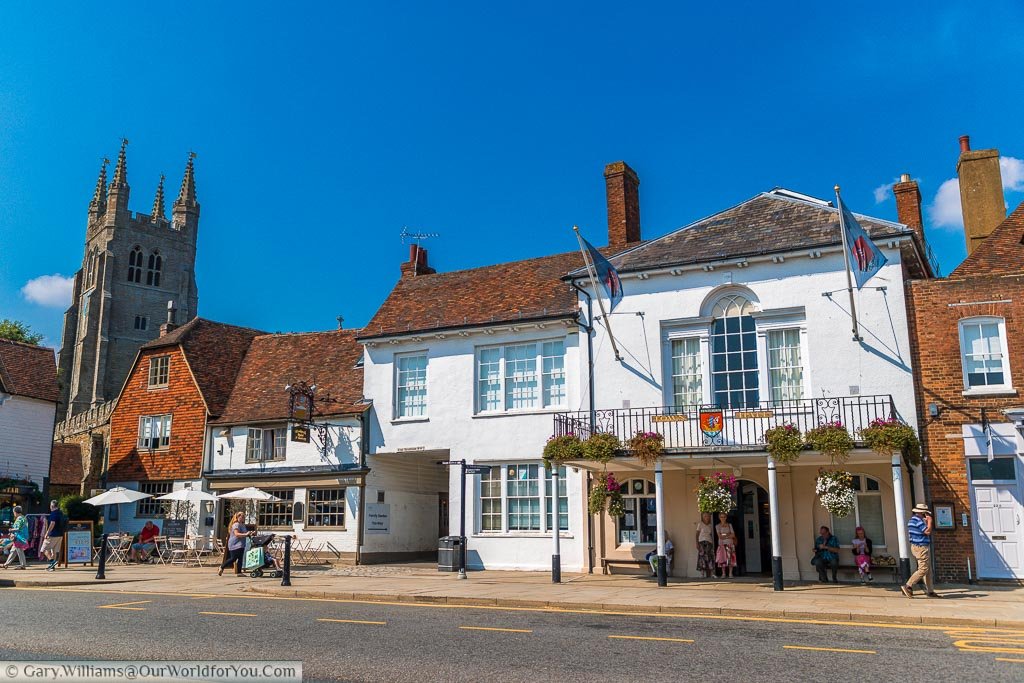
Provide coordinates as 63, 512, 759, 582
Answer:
974, 483, 1024, 579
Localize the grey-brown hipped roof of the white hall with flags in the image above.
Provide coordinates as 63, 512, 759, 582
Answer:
593, 190, 911, 274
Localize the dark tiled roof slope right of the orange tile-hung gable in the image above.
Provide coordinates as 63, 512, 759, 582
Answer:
141, 317, 266, 416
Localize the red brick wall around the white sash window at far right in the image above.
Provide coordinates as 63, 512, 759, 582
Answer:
908, 274, 1024, 582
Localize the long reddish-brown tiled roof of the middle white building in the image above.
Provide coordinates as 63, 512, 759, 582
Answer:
360, 252, 583, 339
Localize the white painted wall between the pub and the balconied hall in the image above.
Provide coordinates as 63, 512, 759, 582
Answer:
364, 323, 587, 571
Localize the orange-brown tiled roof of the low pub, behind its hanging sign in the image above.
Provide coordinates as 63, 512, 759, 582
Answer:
212, 330, 370, 424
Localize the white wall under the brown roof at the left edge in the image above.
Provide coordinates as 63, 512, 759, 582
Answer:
0, 395, 56, 493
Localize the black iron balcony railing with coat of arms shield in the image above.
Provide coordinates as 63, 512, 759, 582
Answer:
554, 394, 896, 454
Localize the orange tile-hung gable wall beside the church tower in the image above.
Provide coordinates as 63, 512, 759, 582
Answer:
106, 347, 207, 481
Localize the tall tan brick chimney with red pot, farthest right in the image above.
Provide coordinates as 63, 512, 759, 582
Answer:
956, 135, 1007, 256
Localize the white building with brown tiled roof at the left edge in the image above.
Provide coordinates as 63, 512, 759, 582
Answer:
0, 339, 58, 511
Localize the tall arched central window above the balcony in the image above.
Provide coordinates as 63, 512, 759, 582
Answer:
711, 293, 760, 409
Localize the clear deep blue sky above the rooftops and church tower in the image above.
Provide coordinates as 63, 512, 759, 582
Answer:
0, 2, 1024, 345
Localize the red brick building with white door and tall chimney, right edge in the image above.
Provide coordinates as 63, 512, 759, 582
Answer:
913, 137, 1024, 582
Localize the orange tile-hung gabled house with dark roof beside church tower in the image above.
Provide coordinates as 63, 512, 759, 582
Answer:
105, 317, 261, 533
